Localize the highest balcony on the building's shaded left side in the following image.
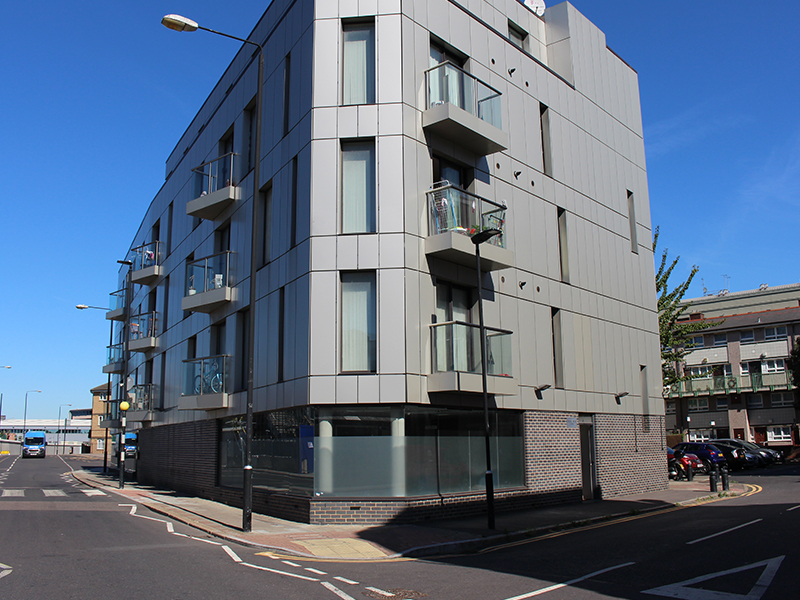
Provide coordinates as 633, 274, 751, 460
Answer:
186, 152, 241, 221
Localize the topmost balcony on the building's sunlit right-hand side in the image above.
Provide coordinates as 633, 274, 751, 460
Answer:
422, 62, 508, 156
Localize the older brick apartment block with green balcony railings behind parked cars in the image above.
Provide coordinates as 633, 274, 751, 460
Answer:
665, 283, 800, 447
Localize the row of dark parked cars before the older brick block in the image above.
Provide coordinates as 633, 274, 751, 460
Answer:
668, 439, 783, 473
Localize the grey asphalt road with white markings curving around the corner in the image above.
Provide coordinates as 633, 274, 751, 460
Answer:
0, 456, 800, 600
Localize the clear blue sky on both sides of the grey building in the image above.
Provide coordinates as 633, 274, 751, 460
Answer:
0, 0, 800, 418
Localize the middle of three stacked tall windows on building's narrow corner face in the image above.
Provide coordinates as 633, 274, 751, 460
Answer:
342, 140, 375, 233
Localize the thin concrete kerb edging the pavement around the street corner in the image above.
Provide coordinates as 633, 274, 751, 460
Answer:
73, 471, 752, 562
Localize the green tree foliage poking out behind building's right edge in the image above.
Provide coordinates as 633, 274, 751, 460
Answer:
653, 227, 719, 386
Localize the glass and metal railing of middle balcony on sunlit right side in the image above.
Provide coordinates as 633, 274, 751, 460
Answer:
428, 181, 507, 248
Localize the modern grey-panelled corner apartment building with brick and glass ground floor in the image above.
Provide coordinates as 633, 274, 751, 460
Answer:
106, 0, 667, 522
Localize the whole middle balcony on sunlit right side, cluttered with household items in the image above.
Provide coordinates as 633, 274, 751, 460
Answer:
425, 181, 514, 271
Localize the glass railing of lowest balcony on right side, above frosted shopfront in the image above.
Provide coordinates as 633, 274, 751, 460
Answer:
430, 321, 512, 377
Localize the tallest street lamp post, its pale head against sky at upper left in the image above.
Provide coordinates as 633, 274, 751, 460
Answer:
161, 15, 264, 532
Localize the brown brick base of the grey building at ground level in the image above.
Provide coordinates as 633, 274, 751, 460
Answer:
137, 411, 668, 524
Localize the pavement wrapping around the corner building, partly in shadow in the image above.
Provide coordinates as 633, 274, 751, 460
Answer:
71, 463, 750, 561
